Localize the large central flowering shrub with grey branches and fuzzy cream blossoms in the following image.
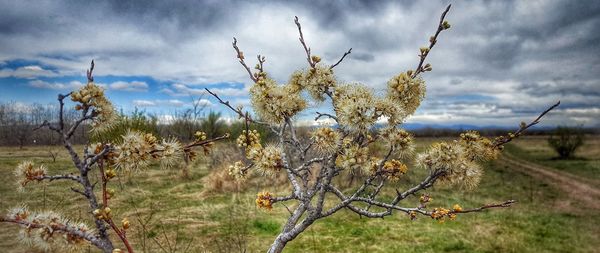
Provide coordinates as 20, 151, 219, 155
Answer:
207, 6, 558, 252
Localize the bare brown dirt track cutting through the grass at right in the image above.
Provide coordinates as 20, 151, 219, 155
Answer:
500, 153, 600, 210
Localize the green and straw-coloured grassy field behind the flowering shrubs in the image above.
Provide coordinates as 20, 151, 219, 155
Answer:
0, 137, 600, 252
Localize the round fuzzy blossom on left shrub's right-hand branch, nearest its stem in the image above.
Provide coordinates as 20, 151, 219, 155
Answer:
115, 131, 159, 170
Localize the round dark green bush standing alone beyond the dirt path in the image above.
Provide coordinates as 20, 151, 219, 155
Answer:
548, 126, 584, 159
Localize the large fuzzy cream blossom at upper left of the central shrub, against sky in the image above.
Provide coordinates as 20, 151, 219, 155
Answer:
250, 75, 306, 123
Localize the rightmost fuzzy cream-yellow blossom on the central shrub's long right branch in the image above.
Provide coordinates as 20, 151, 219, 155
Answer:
458, 131, 499, 161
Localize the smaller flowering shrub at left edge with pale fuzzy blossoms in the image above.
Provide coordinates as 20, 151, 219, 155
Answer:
0, 61, 228, 253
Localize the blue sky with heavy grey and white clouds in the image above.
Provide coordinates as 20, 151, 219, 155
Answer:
0, 0, 600, 126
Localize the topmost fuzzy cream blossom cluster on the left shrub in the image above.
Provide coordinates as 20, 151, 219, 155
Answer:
71, 82, 117, 131
